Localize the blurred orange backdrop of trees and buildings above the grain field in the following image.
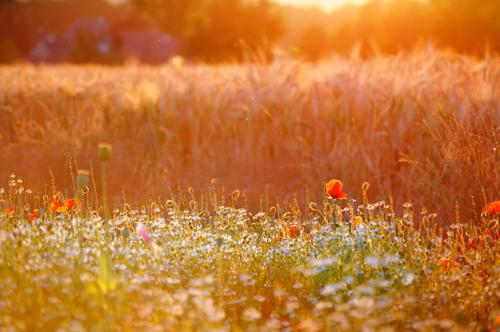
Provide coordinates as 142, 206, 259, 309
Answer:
0, 0, 500, 64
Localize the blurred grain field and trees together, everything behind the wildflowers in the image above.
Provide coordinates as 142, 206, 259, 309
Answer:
0, 0, 500, 222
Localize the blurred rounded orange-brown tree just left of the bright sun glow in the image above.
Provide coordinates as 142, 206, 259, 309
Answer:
133, 0, 283, 61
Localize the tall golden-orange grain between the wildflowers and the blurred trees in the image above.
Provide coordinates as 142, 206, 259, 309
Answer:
0, 50, 500, 222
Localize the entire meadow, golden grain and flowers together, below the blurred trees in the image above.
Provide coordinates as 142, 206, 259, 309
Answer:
0, 48, 500, 331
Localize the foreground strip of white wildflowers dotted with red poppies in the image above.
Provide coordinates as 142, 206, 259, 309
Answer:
0, 166, 500, 331
